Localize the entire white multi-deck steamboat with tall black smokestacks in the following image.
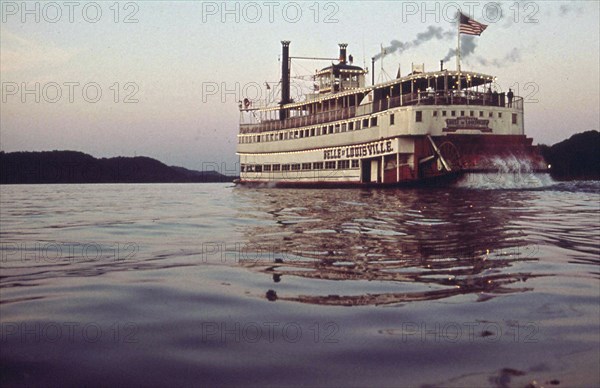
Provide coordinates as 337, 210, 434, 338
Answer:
237, 41, 545, 187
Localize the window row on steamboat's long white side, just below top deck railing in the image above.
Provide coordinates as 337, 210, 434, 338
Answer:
239, 115, 378, 144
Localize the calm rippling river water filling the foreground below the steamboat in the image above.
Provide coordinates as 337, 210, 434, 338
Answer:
0, 179, 600, 387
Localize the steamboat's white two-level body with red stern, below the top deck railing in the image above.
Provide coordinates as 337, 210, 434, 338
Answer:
238, 106, 543, 186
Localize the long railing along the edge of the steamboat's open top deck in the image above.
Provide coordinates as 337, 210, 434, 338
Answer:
240, 91, 523, 134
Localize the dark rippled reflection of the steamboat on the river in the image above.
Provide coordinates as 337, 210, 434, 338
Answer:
236, 190, 537, 306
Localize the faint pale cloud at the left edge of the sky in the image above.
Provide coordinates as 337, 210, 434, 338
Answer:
0, 29, 75, 73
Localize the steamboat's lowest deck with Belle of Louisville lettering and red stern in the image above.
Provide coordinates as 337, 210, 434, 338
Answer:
240, 134, 544, 186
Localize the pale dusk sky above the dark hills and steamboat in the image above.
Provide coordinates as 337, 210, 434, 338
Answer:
0, 1, 600, 174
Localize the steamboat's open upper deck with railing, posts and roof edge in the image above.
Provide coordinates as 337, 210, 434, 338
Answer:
240, 70, 523, 134
